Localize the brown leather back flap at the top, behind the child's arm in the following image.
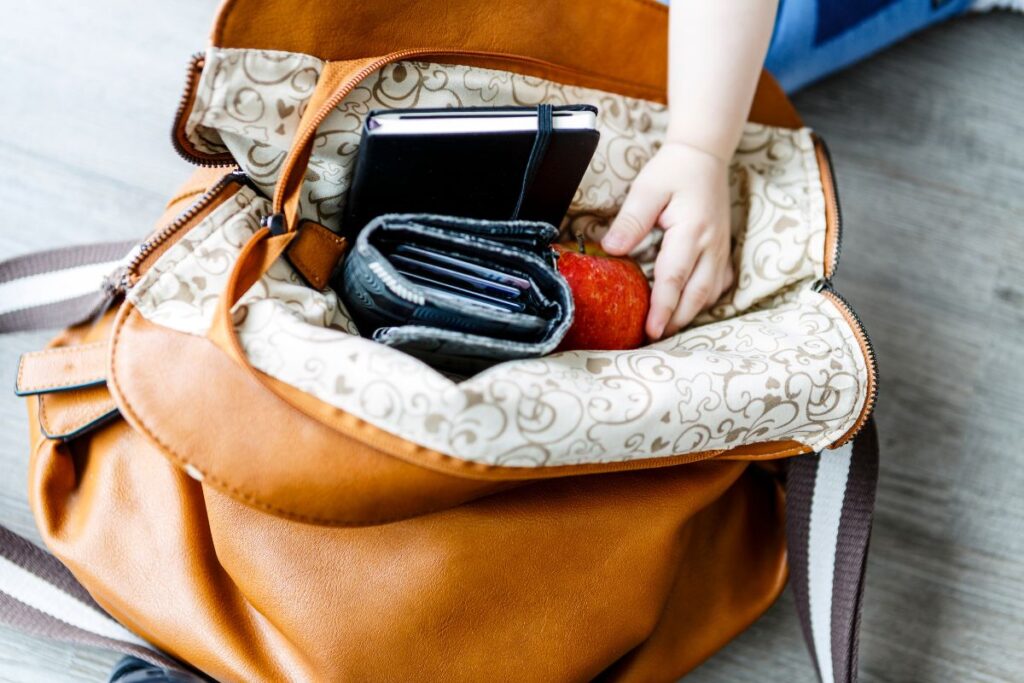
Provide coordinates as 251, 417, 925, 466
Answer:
211, 0, 801, 128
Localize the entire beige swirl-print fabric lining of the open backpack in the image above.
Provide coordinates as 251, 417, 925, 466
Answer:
123, 49, 867, 467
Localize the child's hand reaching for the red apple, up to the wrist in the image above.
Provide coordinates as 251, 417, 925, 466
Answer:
601, 142, 733, 340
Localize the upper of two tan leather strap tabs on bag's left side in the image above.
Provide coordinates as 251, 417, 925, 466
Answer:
14, 341, 108, 396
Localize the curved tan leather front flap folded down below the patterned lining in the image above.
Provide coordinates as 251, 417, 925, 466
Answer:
109, 304, 806, 526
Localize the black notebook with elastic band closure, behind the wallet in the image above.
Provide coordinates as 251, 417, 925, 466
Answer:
342, 104, 599, 240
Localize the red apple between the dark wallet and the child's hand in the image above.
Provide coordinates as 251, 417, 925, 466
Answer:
554, 240, 650, 351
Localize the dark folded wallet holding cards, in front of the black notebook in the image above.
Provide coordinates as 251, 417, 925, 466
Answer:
335, 214, 572, 376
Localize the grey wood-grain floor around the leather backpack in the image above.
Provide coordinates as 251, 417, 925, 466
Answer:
0, 5, 1024, 683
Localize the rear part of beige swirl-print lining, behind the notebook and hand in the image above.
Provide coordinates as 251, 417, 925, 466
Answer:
185, 48, 824, 321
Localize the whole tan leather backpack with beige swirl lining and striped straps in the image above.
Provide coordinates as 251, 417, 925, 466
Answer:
0, 0, 878, 681
